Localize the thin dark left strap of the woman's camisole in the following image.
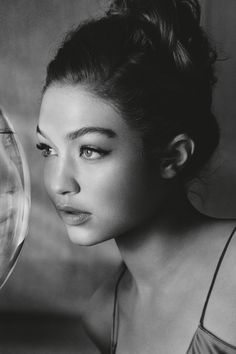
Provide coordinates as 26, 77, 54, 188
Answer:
111, 263, 126, 354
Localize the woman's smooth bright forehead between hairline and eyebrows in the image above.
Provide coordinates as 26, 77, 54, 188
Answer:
39, 85, 128, 134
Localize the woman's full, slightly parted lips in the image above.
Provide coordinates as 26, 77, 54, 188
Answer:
57, 206, 91, 226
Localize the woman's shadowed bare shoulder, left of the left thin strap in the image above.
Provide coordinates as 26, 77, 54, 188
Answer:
81, 264, 123, 354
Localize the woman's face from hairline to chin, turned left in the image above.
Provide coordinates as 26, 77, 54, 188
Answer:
37, 85, 164, 245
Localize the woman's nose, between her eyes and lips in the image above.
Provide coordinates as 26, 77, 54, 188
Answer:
51, 158, 81, 195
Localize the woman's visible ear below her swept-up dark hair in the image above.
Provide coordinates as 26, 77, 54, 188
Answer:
161, 134, 195, 179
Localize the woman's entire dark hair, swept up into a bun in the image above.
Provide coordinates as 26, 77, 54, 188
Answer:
44, 0, 219, 179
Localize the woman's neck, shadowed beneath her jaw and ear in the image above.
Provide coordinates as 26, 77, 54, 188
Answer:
116, 185, 209, 288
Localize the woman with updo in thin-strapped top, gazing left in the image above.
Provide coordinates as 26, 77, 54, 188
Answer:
37, 0, 236, 354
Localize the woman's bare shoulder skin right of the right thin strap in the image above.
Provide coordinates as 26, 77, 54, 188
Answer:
204, 220, 236, 346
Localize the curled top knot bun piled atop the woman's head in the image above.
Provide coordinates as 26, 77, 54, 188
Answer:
107, 0, 216, 77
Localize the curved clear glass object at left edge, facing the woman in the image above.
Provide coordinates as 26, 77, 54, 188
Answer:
0, 107, 30, 288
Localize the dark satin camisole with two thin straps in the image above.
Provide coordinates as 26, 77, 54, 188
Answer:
111, 227, 236, 354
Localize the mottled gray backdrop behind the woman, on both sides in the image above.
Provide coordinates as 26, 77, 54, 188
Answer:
0, 0, 236, 354
